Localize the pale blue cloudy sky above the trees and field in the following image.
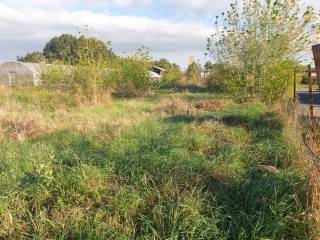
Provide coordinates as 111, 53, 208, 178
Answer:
0, 0, 320, 67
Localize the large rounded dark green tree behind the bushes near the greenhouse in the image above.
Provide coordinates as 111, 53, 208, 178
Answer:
43, 34, 114, 64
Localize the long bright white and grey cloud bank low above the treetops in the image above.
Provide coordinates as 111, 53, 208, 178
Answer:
0, 0, 211, 66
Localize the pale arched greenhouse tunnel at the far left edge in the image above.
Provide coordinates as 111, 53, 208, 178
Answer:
0, 62, 40, 86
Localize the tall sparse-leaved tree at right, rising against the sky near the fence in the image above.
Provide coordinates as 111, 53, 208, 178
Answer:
208, 0, 316, 102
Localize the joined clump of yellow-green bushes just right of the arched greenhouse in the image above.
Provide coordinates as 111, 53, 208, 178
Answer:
41, 38, 150, 99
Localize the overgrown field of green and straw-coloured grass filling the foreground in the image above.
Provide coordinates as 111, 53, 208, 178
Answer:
0, 89, 309, 240
